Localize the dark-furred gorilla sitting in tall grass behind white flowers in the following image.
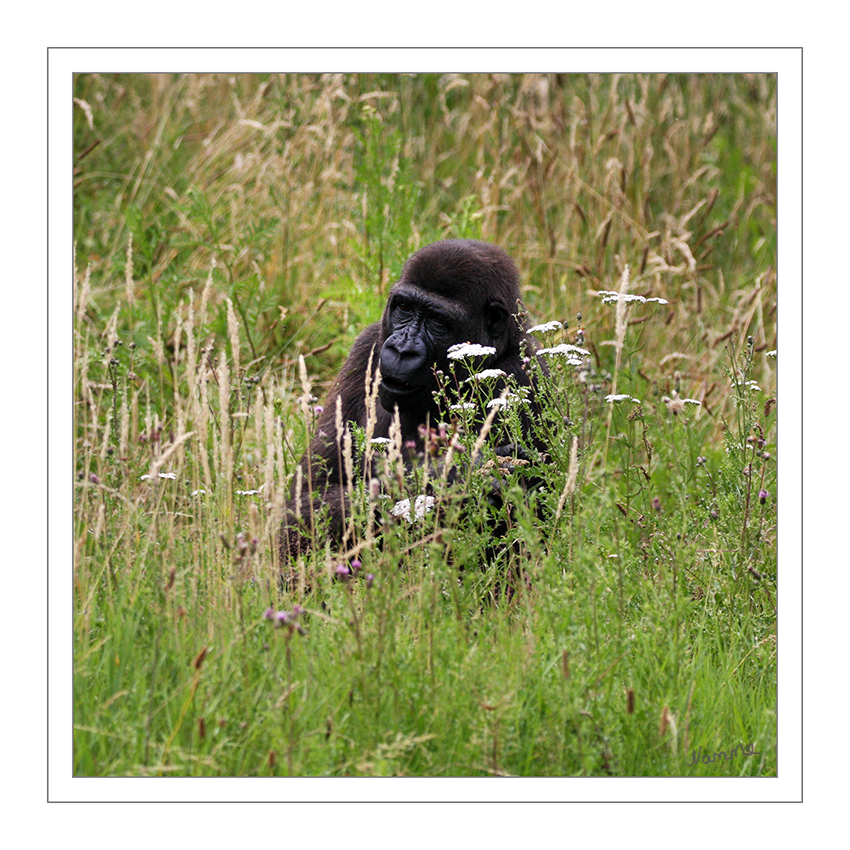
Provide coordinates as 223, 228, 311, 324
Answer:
280, 240, 536, 563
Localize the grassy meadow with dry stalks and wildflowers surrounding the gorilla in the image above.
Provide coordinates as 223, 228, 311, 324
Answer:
72, 74, 778, 777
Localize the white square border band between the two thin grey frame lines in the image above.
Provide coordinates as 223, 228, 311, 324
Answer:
48, 48, 802, 800
